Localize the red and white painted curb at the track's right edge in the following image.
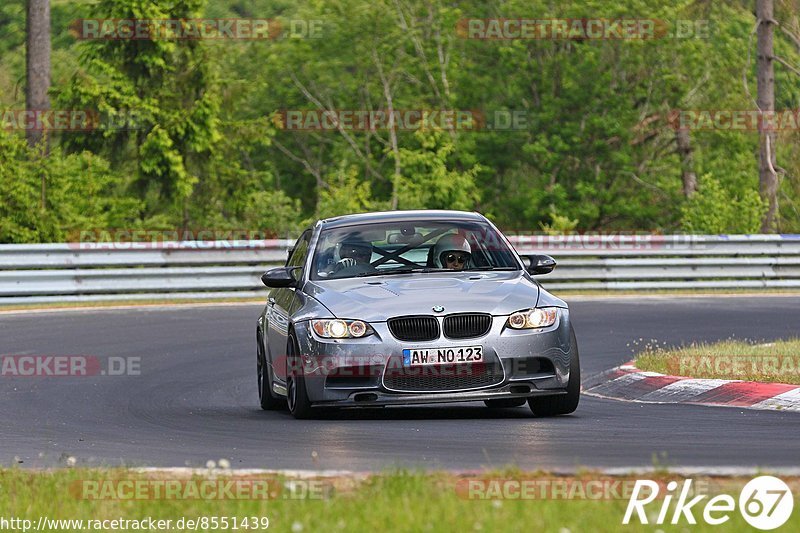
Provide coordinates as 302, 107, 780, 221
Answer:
583, 362, 800, 413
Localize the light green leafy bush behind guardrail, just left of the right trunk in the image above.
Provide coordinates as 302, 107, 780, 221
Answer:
681, 174, 767, 234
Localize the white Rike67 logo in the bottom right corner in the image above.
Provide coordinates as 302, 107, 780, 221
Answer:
622, 476, 794, 530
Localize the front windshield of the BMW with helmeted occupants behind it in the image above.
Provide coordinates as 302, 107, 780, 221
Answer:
311, 221, 520, 280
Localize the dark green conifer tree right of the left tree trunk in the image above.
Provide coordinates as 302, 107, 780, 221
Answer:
59, 0, 220, 224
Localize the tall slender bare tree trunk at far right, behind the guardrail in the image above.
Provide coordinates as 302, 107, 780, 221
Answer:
756, 0, 778, 233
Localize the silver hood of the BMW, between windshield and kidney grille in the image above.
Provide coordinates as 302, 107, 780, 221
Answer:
305, 271, 539, 322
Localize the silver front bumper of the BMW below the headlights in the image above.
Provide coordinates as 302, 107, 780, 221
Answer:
284, 309, 577, 407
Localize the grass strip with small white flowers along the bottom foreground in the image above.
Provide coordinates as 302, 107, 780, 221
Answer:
0, 468, 800, 533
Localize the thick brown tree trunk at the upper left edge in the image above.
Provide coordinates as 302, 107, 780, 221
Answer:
25, 0, 50, 154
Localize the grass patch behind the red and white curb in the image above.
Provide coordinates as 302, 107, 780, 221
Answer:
636, 339, 800, 385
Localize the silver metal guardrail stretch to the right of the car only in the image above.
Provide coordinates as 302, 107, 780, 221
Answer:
512, 235, 800, 290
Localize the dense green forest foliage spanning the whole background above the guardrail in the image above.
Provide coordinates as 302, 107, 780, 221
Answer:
0, 0, 800, 242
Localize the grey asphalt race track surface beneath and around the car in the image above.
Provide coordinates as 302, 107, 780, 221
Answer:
0, 297, 800, 471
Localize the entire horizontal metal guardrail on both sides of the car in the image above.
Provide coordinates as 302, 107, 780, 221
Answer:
0, 234, 800, 305
